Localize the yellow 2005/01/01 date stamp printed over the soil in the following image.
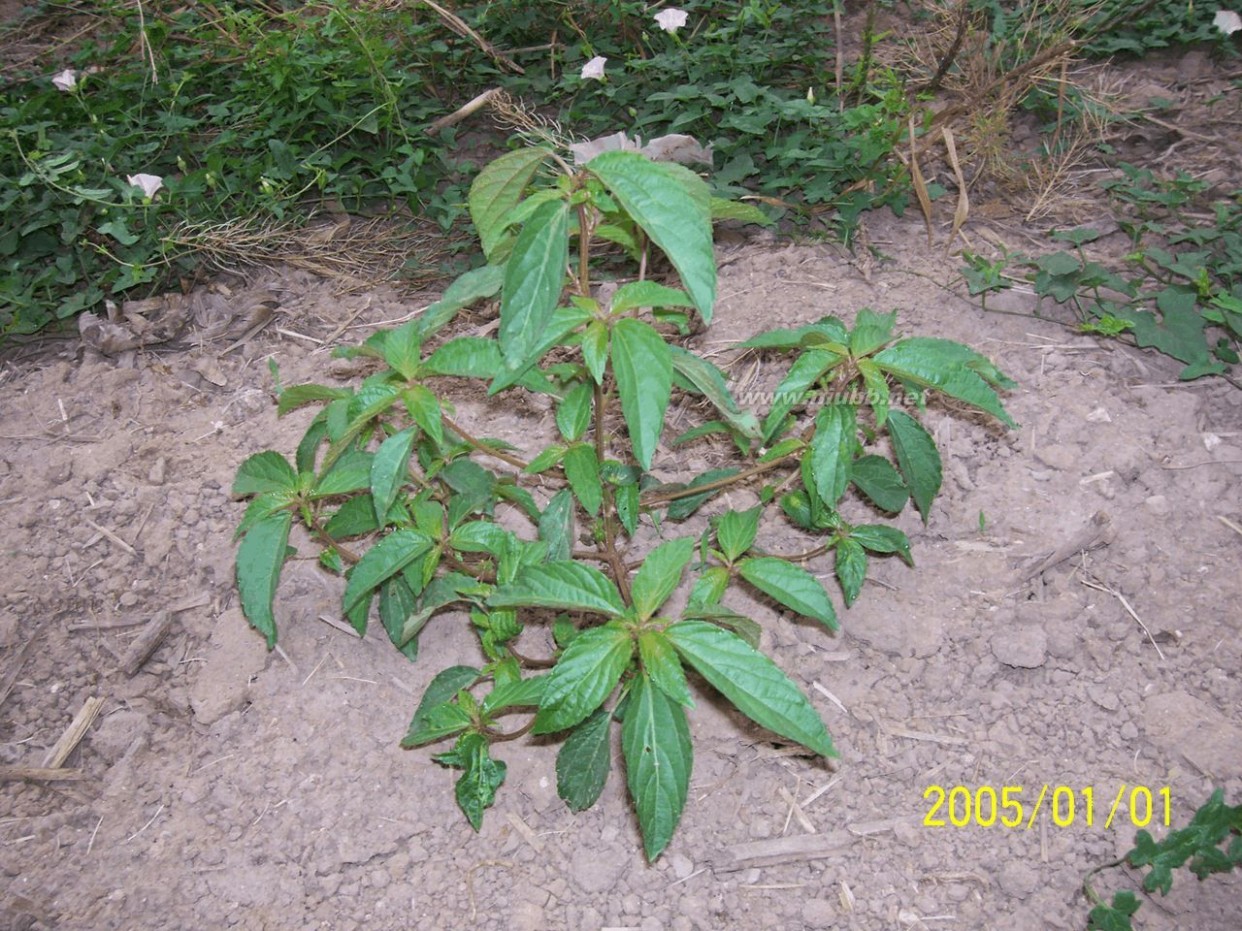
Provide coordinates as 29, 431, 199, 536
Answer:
923, 782, 1172, 830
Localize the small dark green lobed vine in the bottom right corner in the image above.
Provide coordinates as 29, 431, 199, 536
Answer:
1083, 788, 1242, 931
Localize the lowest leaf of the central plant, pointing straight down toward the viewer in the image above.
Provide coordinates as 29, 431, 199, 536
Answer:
621, 675, 694, 860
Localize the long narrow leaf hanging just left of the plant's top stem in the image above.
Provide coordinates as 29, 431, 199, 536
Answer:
499, 201, 570, 370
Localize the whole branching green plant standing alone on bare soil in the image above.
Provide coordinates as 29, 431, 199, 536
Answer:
233, 142, 1011, 859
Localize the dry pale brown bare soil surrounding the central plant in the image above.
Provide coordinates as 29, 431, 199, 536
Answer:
0, 25, 1242, 931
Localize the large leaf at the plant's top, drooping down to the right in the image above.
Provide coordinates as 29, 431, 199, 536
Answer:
586, 151, 715, 323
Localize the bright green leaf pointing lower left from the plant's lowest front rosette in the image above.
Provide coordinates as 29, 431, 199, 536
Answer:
532, 623, 633, 734
